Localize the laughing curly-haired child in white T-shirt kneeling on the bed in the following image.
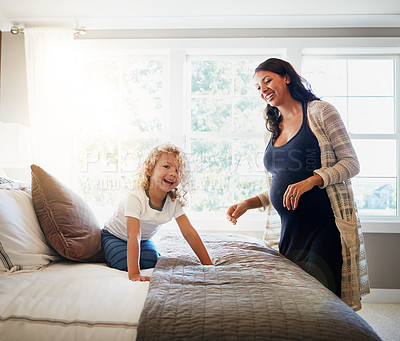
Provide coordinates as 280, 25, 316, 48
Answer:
101, 143, 212, 281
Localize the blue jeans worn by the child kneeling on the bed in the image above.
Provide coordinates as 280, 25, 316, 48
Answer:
101, 229, 160, 271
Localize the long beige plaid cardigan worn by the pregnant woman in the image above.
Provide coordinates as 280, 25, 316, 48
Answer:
258, 101, 370, 311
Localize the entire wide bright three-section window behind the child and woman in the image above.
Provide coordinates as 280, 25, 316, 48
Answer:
72, 41, 400, 231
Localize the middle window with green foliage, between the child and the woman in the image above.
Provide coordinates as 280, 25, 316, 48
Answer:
187, 56, 265, 212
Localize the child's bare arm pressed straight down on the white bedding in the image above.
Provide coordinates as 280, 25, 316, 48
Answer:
126, 217, 150, 281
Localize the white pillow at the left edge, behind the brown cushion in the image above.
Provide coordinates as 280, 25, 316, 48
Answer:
0, 189, 60, 272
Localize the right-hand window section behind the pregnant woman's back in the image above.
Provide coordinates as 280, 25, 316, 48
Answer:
302, 56, 400, 216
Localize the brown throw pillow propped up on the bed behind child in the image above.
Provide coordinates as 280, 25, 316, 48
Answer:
31, 165, 104, 262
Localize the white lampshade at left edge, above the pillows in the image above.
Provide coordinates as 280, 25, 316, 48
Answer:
0, 123, 32, 169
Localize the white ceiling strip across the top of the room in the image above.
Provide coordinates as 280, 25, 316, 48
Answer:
0, 0, 400, 31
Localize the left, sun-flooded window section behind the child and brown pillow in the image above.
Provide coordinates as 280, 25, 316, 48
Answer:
75, 55, 167, 220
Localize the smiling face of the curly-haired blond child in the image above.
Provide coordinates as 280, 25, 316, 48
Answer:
149, 153, 180, 194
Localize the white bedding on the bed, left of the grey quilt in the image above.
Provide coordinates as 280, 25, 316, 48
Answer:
0, 262, 153, 341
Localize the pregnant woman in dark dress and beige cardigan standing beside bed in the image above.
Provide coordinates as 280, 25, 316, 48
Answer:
227, 58, 369, 310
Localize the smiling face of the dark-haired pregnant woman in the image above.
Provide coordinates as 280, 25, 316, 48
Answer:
253, 71, 291, 107
